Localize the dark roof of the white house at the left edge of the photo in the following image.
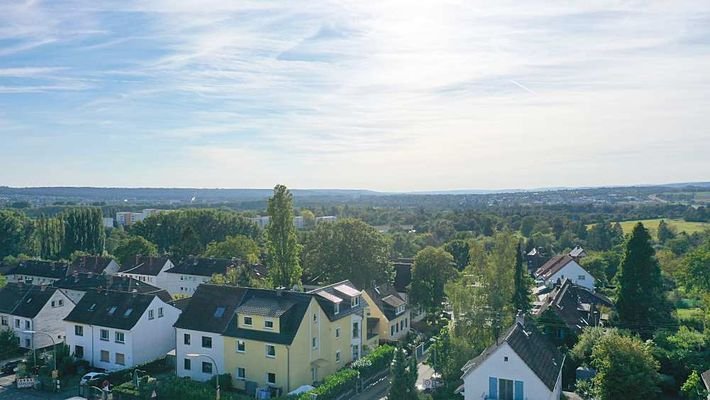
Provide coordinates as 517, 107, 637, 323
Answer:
0, 283, 57, 318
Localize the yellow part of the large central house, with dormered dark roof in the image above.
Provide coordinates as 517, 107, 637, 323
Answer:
223, 281, 366, 395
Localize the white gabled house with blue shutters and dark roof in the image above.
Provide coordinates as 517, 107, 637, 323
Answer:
456, 314, 565, 400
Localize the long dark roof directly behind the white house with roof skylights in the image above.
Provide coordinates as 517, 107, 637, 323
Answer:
52, 272, 172, 303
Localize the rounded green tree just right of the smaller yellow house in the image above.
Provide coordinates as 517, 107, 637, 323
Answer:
410, 246, 456, 314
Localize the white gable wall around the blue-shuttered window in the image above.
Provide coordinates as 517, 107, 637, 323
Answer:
464, 343, 561, 400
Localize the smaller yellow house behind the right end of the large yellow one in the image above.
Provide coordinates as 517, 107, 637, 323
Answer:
363, 284, 411, 342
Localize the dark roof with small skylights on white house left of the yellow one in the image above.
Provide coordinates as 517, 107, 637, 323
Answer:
64, 290, 157, 330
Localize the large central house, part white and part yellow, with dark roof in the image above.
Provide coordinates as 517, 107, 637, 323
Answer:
175, 281, 366, 396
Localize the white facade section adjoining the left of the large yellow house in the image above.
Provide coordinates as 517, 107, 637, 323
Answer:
175, 328, 229, 381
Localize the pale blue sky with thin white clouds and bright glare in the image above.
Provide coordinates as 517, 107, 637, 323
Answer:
0, 0, 710, 191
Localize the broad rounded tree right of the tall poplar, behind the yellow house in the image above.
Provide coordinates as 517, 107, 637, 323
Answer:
303, 218, 392, 288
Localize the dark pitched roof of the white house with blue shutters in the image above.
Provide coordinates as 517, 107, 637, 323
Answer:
461, 322, 564, 390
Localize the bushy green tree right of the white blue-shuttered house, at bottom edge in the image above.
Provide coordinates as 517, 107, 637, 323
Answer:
592, 335, 659, 400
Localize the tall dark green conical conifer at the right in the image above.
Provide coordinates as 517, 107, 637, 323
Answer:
616, 222, 672, 338
